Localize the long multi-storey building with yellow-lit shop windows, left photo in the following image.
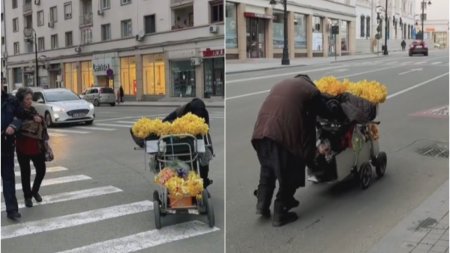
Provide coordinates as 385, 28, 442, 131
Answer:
2, 0, 224, 100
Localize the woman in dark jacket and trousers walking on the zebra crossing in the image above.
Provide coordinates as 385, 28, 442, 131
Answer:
16, 88, 48, 207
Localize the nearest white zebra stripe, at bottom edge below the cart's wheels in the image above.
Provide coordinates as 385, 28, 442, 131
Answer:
59, 221, 220, 253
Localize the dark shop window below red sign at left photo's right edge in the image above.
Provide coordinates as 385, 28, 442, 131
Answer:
203, 58, 224, 98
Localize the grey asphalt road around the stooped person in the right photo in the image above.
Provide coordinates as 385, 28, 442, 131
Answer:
226, 51, 449, 253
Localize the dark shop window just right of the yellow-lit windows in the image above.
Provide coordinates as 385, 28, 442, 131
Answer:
170, 60, 196, 97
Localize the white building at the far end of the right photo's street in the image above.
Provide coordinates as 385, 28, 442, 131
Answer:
355, 0, 416, 53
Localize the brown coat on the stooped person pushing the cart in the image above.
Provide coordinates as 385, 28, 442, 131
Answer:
252, 77, 320, 161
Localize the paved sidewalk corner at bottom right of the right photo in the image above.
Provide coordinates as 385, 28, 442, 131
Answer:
369, 180, 449, 253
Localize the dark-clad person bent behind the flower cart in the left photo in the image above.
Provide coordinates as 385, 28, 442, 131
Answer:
163, 98, 214, 188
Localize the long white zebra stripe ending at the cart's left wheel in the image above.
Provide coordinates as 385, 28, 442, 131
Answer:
1, 200, 153, 239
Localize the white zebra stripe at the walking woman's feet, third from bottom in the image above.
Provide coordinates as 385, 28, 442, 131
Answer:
2, 186, 122, 211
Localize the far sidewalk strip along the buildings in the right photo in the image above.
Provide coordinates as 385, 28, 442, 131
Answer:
225, 50, 408, 74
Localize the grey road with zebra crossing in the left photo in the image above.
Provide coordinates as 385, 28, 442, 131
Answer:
1, 106, 224, 253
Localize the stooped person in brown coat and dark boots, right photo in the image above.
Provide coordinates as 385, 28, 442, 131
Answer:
251, 75, 338, 226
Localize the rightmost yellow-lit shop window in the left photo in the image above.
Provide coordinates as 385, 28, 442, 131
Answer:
142, 55, 166, 96
